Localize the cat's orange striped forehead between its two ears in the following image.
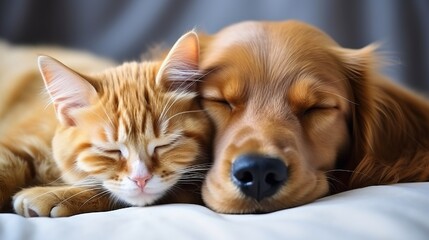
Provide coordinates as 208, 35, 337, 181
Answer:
93, 62, 191, 142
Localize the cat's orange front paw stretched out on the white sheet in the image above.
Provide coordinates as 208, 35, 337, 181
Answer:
13, 186, 109, 217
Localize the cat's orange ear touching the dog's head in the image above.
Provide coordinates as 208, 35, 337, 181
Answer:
156, 31, 200, 92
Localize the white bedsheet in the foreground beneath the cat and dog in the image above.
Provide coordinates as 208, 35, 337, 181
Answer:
0, 183, 429, 240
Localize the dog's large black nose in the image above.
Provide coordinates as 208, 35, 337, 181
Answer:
231, 154, 287, 201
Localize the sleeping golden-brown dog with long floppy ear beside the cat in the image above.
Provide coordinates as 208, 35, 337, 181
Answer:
199, 21, 429, 213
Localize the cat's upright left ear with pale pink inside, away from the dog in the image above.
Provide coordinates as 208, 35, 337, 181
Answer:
38, 56, 97, 126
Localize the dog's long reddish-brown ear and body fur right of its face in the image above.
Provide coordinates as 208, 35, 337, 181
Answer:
334, 45, 429, 188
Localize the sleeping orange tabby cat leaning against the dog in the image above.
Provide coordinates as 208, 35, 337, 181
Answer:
0, 31, 211, 217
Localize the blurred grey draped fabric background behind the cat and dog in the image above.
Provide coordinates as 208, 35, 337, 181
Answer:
0, 0, 429, 93
